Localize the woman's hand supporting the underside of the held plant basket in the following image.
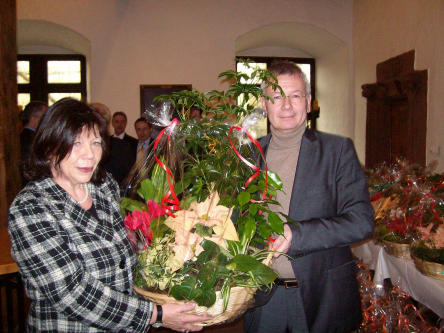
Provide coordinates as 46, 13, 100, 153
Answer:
153, 303, 212, 332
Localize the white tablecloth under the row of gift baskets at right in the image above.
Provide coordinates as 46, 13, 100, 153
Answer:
352, 240, 444, 318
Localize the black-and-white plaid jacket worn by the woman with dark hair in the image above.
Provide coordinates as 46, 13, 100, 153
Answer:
8, 176, 153, 333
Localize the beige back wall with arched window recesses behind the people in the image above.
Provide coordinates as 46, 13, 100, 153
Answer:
17, 0, 353, 137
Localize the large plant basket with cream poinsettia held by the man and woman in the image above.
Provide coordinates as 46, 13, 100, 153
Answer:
121, 64, 292, 325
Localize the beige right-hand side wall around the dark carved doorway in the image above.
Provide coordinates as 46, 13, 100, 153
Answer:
353, 0, 444, 171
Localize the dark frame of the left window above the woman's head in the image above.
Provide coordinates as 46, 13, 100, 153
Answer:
17, 54, 87, 103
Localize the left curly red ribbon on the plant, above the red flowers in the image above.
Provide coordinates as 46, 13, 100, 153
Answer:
153, 118, 180, 217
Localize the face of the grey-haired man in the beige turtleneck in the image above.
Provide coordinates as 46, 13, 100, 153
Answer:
262, 74, 311, 134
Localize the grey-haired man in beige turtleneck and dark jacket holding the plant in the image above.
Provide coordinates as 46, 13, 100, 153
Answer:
244, 62, 373, 333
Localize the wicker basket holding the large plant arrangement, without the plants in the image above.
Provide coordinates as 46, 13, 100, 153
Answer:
134, 286, 256, 326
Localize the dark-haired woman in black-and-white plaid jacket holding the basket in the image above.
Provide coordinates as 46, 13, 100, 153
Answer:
8, 98, 208, 332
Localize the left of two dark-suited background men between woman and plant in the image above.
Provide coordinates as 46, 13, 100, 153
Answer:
103, 111, 137, 186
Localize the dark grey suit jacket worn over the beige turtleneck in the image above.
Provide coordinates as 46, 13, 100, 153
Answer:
261, 129, 374, 332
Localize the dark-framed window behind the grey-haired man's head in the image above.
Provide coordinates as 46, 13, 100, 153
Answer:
236, 57, 319, 138
